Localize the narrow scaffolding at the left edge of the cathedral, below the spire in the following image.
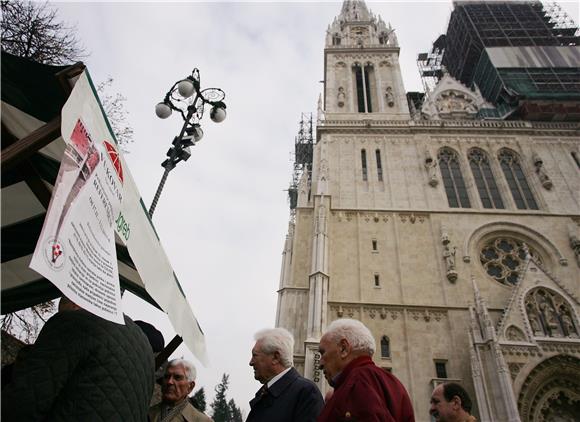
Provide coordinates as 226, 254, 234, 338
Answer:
288, 113, 314, 215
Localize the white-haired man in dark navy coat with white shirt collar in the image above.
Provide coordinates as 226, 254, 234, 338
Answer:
246, 328, 324, 422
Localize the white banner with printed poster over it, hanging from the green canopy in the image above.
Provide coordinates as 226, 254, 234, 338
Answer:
30, 70, 209, 366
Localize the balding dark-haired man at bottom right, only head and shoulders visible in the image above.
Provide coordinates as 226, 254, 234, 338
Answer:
429, 382, 476, 422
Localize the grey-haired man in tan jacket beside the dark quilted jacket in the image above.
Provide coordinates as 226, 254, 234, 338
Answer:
149, 359, 211, 422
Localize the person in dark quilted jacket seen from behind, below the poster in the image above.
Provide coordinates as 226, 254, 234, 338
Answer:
2, 298, 154, 422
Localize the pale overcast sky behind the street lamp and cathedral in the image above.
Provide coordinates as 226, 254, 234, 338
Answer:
51, 1, 578, 414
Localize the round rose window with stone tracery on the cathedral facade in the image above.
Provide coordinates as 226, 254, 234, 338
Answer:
480, 237, 542, 285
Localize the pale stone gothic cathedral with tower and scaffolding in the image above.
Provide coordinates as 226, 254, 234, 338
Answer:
276, 0, 580, 422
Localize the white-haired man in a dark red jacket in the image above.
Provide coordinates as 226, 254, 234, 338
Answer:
318, 319, 415, 422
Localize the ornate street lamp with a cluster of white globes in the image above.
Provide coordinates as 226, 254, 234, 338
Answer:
149, 68, 226, 217
